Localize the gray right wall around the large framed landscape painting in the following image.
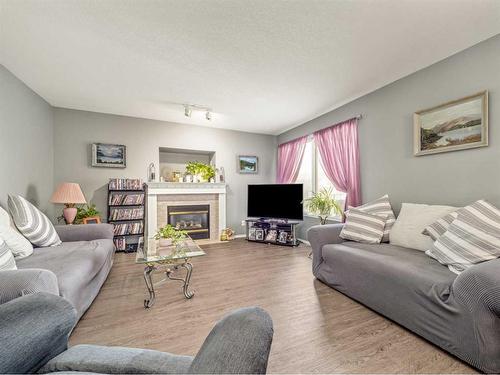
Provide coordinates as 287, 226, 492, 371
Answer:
278, 35, 500, 235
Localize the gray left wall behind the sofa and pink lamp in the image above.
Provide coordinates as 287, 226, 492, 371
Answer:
0, 65, 54, 217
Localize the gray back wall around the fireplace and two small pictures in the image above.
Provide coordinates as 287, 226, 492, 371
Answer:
54, 108, 276, 233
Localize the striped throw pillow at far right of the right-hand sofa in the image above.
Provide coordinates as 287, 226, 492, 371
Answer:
425, 200, 500, 274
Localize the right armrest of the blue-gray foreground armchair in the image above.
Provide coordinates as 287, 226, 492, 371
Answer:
189, 307, 273, 374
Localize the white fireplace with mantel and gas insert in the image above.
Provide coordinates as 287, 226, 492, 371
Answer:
145, 182, 226, 243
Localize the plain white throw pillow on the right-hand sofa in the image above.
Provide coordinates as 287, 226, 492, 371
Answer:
389, 203, 458, 251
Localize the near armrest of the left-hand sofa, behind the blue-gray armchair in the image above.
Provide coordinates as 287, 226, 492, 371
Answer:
0, 268, 59, 304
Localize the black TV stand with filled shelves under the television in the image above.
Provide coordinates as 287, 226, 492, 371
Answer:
245, 218, 300, 246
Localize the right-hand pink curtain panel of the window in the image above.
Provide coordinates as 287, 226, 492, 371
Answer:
314, 119, 361, 208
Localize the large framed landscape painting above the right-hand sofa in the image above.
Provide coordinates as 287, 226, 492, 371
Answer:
413, 91, 488, 156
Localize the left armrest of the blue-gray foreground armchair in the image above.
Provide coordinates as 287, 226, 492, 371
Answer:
0, 293, 76, 374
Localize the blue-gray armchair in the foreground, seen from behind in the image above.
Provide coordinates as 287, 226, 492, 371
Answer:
0, 293, 273, 374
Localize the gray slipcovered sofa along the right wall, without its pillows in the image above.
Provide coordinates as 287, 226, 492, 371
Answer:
308, 224, 500, 373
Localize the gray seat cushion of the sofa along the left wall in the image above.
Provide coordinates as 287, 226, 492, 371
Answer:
17, 239, 114, 312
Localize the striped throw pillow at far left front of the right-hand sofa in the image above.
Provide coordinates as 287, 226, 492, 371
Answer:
340, 208, 387, 243
